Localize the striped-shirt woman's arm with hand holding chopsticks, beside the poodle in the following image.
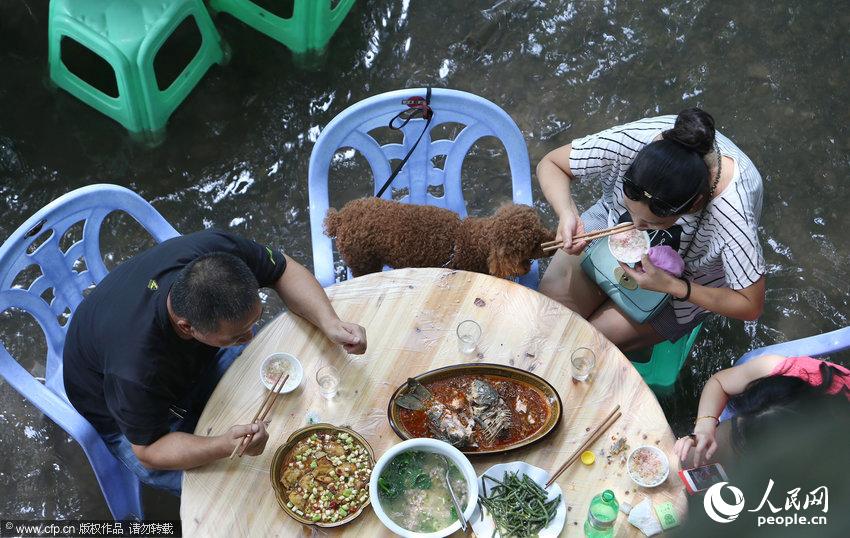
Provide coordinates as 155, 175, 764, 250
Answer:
537, 144, 587, 251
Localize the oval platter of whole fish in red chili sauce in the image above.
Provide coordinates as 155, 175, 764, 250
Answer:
387, 363, 562, 456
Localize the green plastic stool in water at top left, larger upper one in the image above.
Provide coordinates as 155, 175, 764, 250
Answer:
48, 0, 225, 141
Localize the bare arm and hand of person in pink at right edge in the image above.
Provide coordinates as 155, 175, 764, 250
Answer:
673, 355, 785, 467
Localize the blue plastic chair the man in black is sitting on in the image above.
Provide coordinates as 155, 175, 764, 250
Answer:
0, 185, 179, 520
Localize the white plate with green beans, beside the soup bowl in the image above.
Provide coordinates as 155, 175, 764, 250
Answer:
470, 461, 567, 538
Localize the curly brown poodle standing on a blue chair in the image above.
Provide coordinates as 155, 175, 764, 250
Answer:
325, 198, 555, 278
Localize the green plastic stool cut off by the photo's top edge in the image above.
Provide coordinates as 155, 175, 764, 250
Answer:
210, 0, 354, 54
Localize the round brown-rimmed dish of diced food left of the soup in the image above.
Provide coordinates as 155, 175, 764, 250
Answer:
271, 424, 375, 527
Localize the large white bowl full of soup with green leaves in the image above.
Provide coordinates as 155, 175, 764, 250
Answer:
369, 438, 478, 538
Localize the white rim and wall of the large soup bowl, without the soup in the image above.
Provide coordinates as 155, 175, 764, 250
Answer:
369, 437, 478, 538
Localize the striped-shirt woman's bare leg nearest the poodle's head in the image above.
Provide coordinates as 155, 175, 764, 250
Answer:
538, 250, 608, 319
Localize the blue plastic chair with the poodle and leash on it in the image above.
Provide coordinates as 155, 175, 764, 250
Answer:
308, 88, 538, 288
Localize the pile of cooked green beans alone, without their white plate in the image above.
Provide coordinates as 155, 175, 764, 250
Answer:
478, 472, 561, 538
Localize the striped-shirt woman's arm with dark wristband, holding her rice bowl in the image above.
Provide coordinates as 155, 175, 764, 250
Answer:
620, 256, 765, 321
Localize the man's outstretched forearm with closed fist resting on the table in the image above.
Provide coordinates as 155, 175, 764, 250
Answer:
274, 256, 366, 354
